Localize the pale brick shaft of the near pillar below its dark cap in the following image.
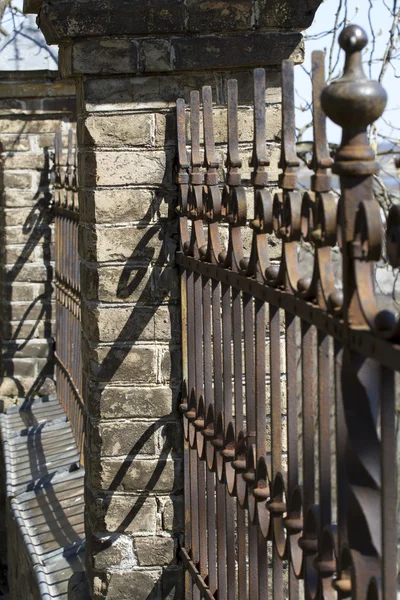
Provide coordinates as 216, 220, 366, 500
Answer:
78, 71, 280, 600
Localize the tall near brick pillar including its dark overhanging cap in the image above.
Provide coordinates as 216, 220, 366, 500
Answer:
27, 0, 319, 600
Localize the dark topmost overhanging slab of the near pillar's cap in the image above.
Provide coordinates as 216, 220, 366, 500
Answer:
24, 0, 322, 44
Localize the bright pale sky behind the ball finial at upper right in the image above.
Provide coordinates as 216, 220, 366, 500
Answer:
295, 0, 400, 143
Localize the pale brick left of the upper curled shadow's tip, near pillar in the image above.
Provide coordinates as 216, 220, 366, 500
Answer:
80, 188, 157, 224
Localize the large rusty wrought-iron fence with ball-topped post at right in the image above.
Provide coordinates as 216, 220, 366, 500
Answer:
176, 26, 400, 600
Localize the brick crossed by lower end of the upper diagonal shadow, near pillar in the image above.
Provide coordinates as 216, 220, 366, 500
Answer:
83, 344, 156, 384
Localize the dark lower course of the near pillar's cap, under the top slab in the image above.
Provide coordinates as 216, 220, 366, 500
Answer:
59, 31, 304, 77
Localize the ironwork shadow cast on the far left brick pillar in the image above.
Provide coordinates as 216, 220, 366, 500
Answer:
0, 143, 54, 402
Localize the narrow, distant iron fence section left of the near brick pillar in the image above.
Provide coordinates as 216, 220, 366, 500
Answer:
53, 130, 84, 456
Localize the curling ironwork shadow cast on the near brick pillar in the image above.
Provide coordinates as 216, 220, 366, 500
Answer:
83, 119, 183, 600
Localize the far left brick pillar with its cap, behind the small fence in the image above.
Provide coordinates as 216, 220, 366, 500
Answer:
0, 71, 76, 396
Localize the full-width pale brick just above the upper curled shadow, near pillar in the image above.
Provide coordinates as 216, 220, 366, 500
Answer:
79, 150, 173, 188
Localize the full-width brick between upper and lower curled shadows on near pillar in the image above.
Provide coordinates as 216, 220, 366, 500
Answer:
87, 385, 178, 419
